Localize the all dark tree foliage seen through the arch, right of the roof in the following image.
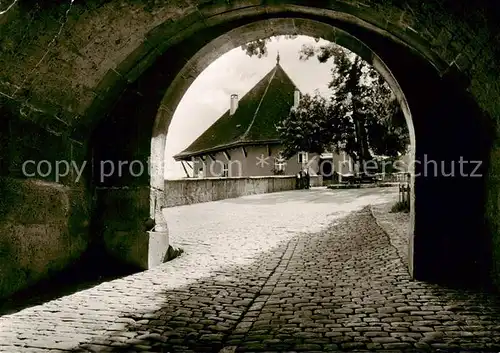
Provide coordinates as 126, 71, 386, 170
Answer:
243, 38, 409, 163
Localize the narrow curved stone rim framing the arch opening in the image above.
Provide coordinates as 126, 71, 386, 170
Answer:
151, 18, 416, 272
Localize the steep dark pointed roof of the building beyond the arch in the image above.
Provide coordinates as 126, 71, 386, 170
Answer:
174, 62, 297, 160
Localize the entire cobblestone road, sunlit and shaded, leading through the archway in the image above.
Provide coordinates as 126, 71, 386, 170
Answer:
0, 190, 500, 352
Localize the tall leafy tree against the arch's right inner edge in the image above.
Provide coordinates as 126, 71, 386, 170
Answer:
294, 43, 409, 163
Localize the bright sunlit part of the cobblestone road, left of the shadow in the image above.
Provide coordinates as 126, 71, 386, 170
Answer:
0, 188, 397, 352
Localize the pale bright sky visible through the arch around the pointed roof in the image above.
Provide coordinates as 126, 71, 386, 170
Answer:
165, 36, 338, 179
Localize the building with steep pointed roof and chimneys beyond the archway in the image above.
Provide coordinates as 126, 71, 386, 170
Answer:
174, 55, 354, 177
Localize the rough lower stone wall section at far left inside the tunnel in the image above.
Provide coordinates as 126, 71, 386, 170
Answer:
0, 178, 89, 298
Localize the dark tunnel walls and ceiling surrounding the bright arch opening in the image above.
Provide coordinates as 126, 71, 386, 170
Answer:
0, 1, 500, 302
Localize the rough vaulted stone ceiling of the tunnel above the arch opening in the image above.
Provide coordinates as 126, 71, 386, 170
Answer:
0, 0, 500, 146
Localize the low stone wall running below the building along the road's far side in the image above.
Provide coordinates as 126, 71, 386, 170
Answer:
165, 175, 322, 207
